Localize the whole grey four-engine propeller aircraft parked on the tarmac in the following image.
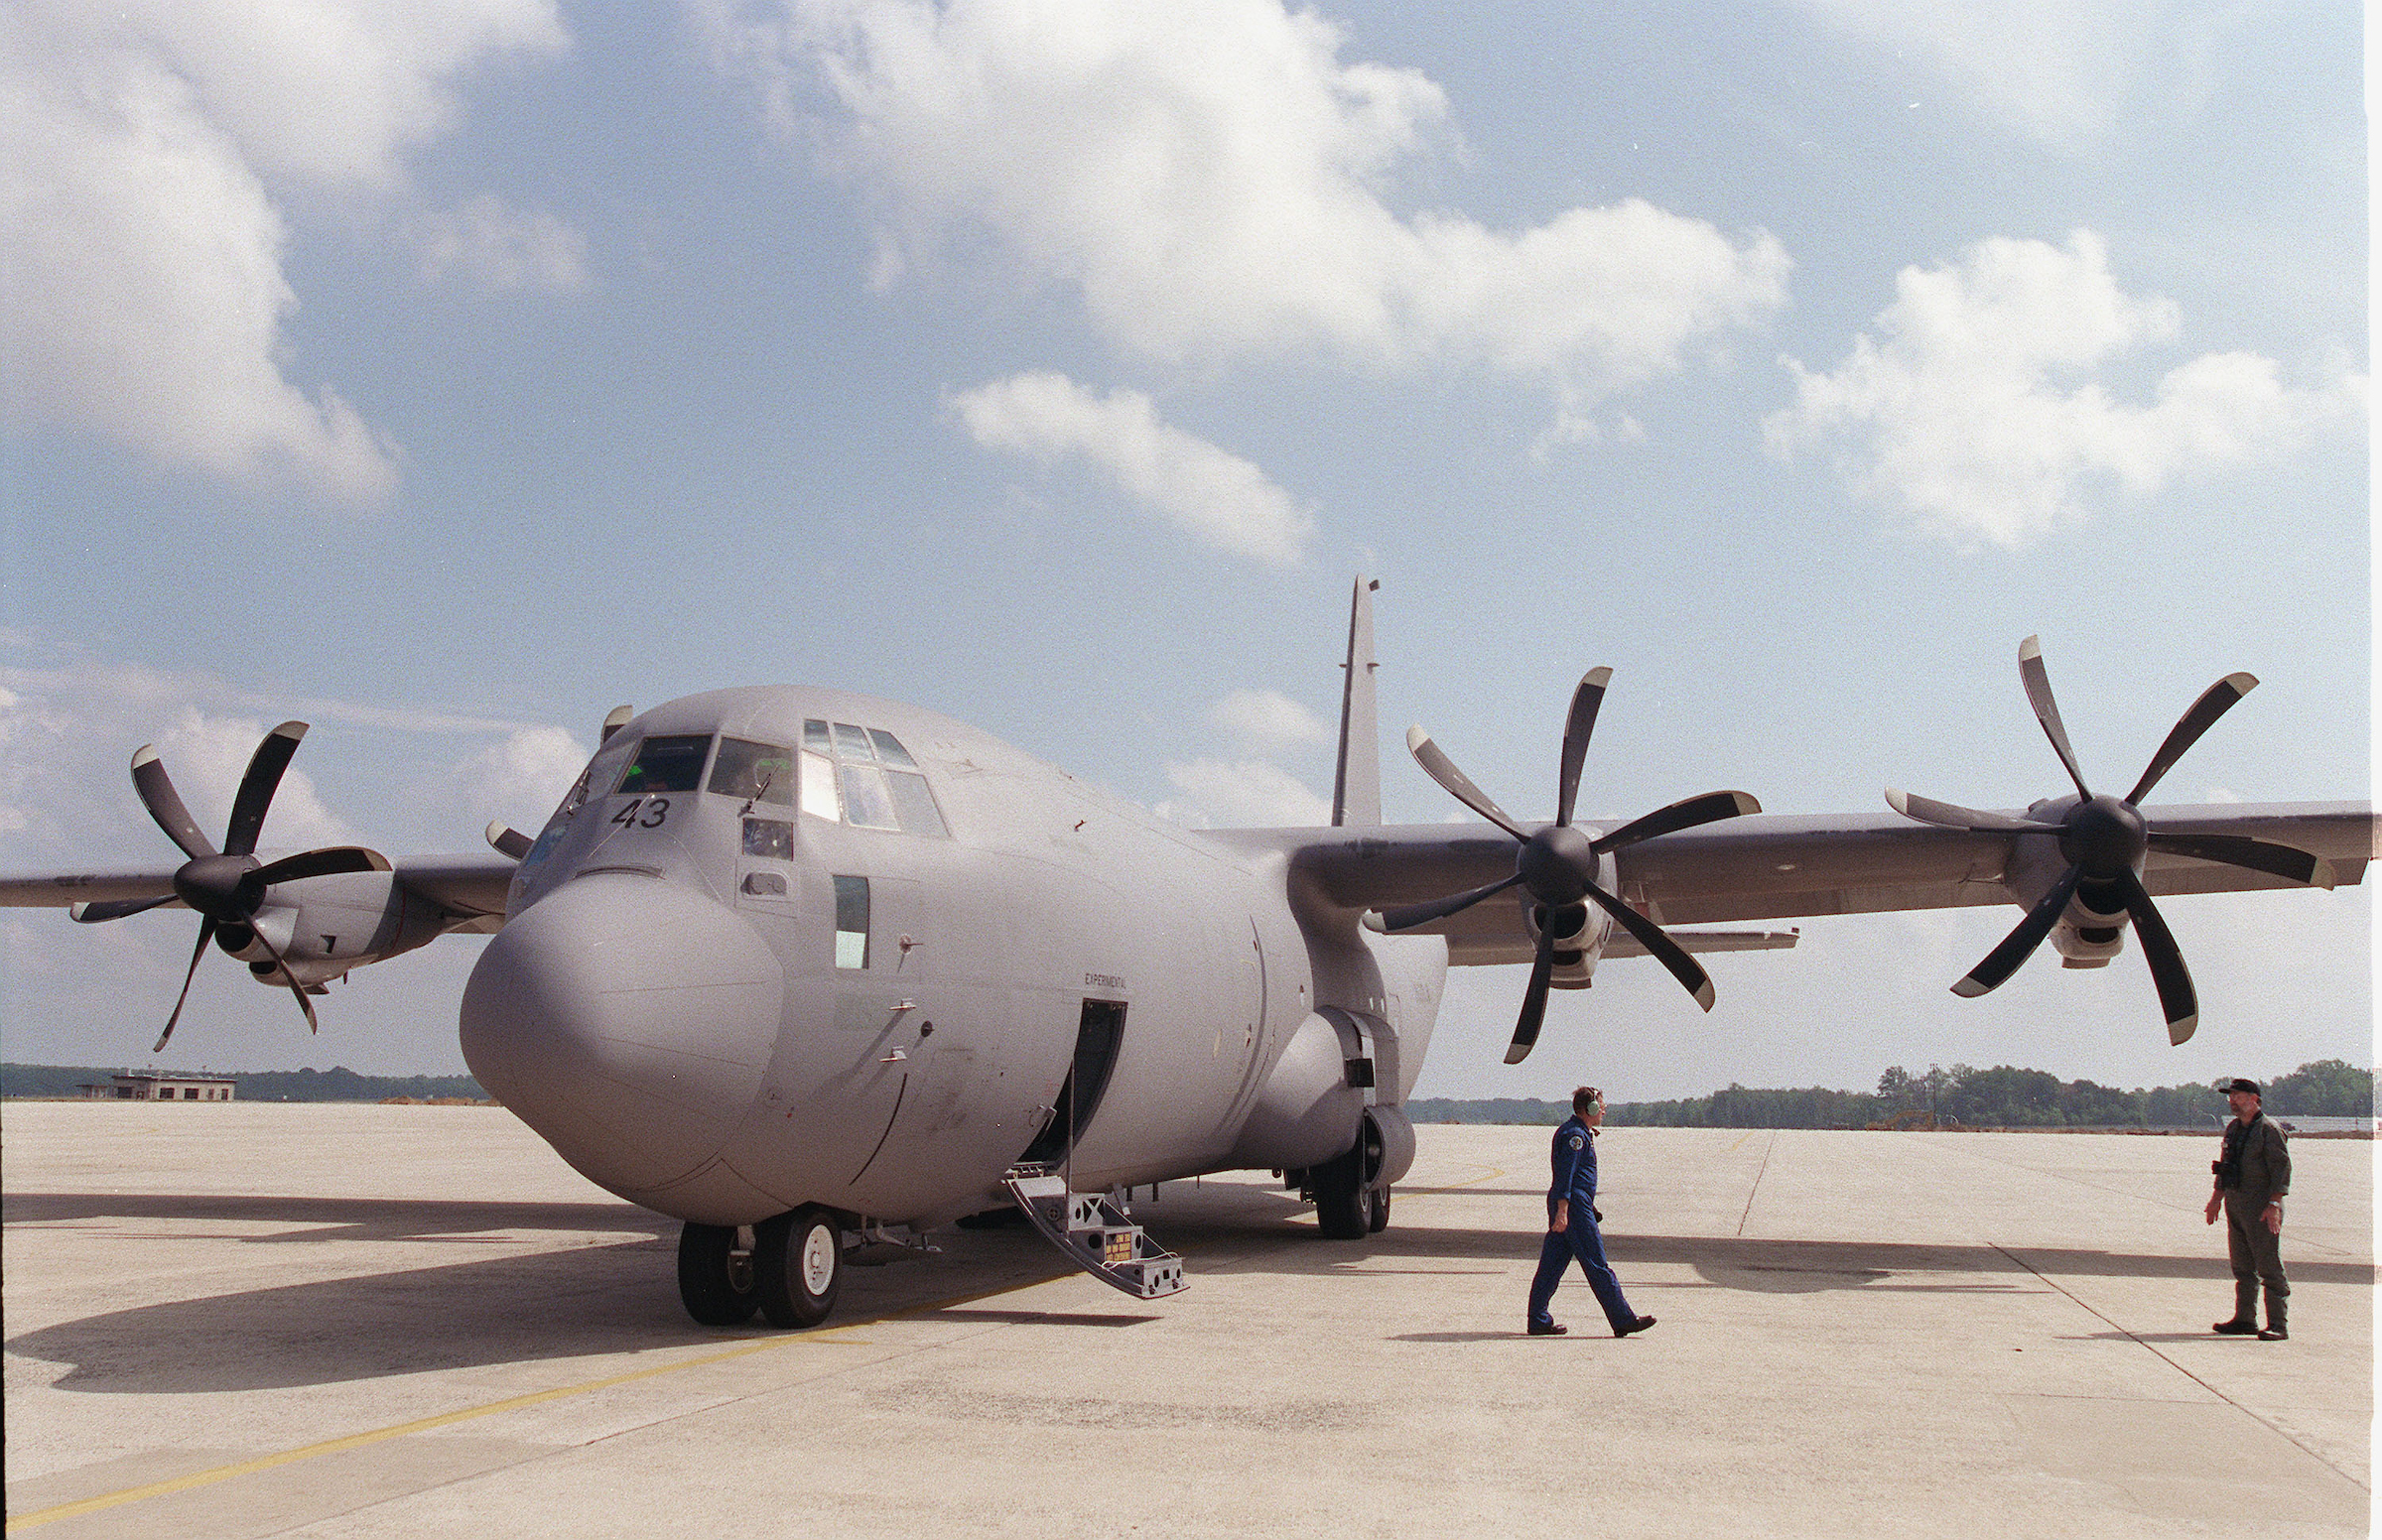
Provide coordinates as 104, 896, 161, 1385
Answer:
0, 578, 2375, 1326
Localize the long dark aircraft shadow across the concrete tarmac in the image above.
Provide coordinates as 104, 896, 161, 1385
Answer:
7, 1186, 2375, 1395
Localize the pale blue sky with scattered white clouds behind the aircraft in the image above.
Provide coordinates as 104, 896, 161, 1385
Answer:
0, 0, 2372, 1097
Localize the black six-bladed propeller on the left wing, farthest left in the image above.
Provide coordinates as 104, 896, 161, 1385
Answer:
71, 721, 388, 1052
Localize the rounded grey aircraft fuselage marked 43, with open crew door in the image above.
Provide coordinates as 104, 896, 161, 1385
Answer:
463, 688, 1446, 1225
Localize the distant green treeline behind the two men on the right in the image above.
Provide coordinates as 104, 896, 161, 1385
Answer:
1405, 1059, 2375, 1128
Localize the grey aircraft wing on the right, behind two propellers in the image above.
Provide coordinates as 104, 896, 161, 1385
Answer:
1257, 802, 2375, 963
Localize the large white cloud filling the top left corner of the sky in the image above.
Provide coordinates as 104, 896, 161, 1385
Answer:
0, 0, 562, 502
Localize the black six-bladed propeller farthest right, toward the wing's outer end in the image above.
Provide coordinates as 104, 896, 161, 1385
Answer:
1887, 635, 2334, 1045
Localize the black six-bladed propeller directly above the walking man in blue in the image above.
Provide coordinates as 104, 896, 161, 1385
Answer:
1380, 669, 1763, 1064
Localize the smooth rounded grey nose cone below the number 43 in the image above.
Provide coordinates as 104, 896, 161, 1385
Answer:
463, 873, 784, 1195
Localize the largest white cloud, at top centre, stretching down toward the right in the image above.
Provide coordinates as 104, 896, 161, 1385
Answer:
713, 0, 1788, 423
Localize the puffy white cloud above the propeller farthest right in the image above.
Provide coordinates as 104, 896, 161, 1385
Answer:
1763, 231, 2365, 548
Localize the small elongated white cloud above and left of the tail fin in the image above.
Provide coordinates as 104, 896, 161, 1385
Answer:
951, 374, 1315, 567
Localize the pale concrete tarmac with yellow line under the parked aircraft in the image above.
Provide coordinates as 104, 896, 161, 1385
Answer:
0, 1102, 2375, 1540
